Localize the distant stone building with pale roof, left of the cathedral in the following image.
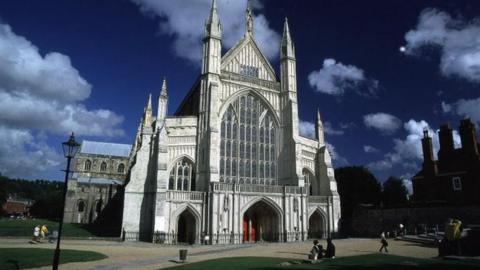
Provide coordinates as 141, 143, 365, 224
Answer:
64, 141, 132, 223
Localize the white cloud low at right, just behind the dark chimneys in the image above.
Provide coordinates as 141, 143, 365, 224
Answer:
368, 119, 461, 170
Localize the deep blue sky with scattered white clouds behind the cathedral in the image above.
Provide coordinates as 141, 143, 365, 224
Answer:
0, 0, 480, 190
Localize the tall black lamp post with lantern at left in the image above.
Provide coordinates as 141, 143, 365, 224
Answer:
52, 132, 80, 270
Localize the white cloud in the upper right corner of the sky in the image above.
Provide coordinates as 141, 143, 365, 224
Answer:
405, 8, 480, 83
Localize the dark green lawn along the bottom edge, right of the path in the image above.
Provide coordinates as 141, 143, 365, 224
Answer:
162, 254, 480, 270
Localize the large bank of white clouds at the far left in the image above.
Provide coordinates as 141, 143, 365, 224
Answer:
0, 24, 124, 176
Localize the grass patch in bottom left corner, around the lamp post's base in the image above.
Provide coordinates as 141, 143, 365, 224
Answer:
0, 248, 107, 270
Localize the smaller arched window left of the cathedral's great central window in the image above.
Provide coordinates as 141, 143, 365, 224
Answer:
168, 158, 195, 191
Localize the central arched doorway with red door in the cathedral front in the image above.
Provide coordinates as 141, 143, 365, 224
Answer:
243, 201, 280, 242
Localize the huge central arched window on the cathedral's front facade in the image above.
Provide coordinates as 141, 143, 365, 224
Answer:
220, 95, 278, 185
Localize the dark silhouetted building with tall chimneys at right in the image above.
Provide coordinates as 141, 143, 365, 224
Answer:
413, 119, 480, 204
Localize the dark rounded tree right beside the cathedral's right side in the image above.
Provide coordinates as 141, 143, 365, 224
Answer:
335, 166, 382, 234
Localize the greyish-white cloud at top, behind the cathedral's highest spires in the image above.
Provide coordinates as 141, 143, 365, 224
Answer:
132, 0, 280, 64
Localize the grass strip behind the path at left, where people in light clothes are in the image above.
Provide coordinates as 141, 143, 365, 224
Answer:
0, 219, 95, 237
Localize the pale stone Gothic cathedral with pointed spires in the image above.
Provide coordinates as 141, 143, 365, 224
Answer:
122, 0, 340, 244
